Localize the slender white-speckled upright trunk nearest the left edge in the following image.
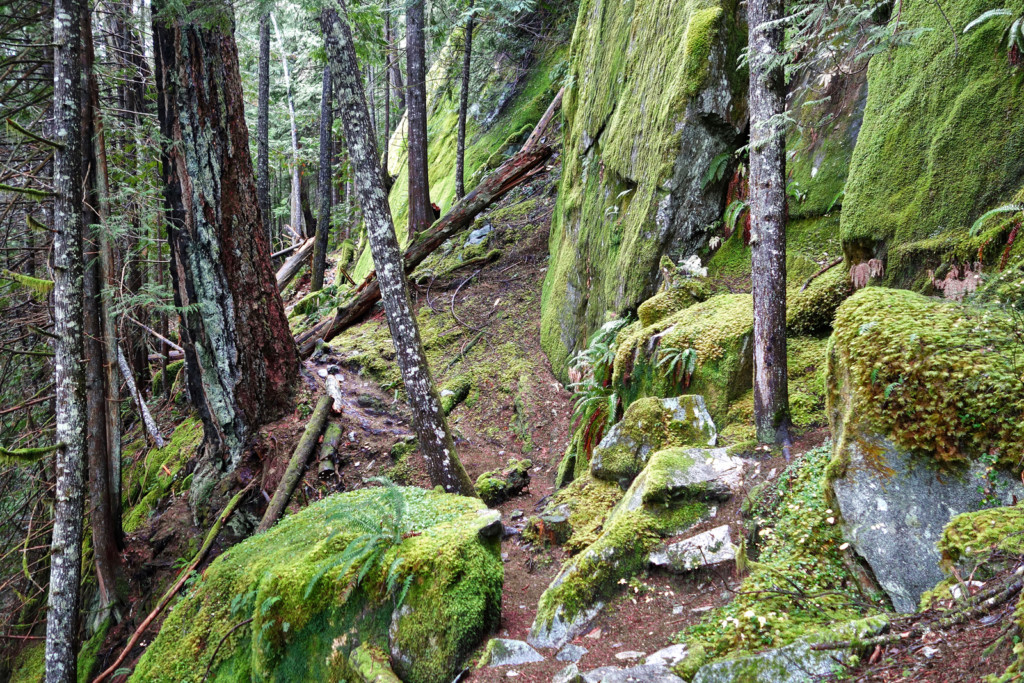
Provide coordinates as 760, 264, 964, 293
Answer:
44, 0, 86, 683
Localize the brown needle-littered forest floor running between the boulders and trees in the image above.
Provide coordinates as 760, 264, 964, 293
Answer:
86, 164, 1012, 683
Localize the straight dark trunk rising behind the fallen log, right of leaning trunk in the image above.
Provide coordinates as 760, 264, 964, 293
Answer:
406, 0, 434, 238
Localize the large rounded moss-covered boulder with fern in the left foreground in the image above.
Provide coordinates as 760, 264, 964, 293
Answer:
131, 487, 503, 683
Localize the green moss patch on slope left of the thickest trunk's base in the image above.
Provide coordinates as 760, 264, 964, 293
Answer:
122, 416, 203, 533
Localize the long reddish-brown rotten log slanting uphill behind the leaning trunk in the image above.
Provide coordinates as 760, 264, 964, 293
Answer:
296, 145, 552, 358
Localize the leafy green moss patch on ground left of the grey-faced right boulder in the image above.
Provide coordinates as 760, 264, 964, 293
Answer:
678, 445, 881, 668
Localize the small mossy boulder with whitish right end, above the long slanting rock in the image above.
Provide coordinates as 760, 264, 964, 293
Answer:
590, 395, 718, 485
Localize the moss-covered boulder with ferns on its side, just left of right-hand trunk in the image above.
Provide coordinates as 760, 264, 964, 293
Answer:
612, 294, 754, 423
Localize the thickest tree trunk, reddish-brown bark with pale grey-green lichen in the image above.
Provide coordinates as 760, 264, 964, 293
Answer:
153, 0, 298, 518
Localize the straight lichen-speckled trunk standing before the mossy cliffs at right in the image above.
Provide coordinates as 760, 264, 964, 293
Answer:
748, 0, 790, 442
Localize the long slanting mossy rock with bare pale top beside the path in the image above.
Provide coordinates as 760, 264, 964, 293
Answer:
529, 449, 741, 647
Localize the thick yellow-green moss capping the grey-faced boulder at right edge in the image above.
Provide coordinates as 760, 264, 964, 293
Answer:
827, 287, 1024, 470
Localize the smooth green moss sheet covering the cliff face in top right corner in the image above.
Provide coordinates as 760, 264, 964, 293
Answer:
842, 0, 1024, 286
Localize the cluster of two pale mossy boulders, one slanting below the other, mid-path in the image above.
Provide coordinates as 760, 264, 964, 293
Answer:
529, 395, 743, 647
